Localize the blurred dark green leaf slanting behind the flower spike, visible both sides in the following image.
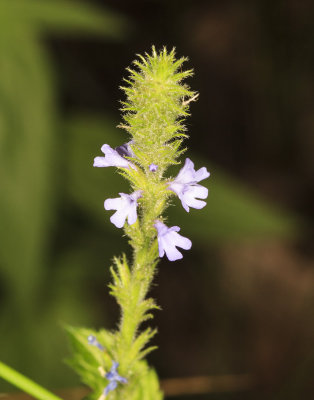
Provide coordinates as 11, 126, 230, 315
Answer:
66, 116, 298, 242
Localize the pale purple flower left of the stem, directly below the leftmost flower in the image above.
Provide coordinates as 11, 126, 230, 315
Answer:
104, 190, 142, 228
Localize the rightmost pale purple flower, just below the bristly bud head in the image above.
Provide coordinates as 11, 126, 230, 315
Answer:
169, 158, 210, 212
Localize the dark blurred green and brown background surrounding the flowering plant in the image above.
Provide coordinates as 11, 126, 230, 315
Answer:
0, 0, 314, 400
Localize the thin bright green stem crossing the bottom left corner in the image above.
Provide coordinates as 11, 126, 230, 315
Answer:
0, 361, 61, 400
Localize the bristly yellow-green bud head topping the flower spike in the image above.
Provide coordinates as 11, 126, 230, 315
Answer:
120, 47, 197, 173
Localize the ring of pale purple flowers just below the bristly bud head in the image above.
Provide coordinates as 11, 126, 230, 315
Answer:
94, 142, 210, 261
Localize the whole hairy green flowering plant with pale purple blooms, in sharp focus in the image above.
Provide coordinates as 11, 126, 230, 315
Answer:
68, 47, 209, 400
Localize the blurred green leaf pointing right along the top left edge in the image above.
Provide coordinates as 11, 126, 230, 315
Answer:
0, 0, 127, 38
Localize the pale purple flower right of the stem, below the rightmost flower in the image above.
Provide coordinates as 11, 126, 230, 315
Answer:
154, 220, 192, 261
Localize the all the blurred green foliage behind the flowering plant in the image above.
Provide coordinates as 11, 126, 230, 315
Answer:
0, 0, 298, 388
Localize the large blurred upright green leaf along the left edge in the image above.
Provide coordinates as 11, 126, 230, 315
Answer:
0, 30, 55, 306
